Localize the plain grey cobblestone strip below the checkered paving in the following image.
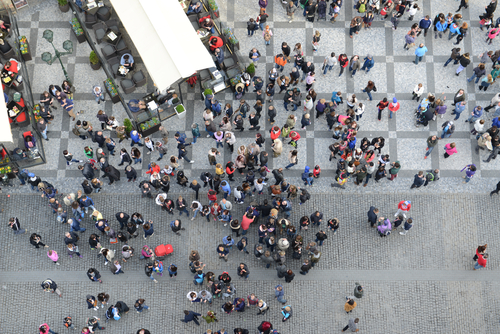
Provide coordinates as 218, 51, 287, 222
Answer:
0, 193, 500, 333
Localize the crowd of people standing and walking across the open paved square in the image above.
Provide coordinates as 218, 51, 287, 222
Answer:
12, 0, 500, 334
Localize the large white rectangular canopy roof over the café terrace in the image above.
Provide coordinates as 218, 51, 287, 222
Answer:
111, 0, 214, 90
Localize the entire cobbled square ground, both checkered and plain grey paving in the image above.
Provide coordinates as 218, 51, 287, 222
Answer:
0, 0, 500, 334
